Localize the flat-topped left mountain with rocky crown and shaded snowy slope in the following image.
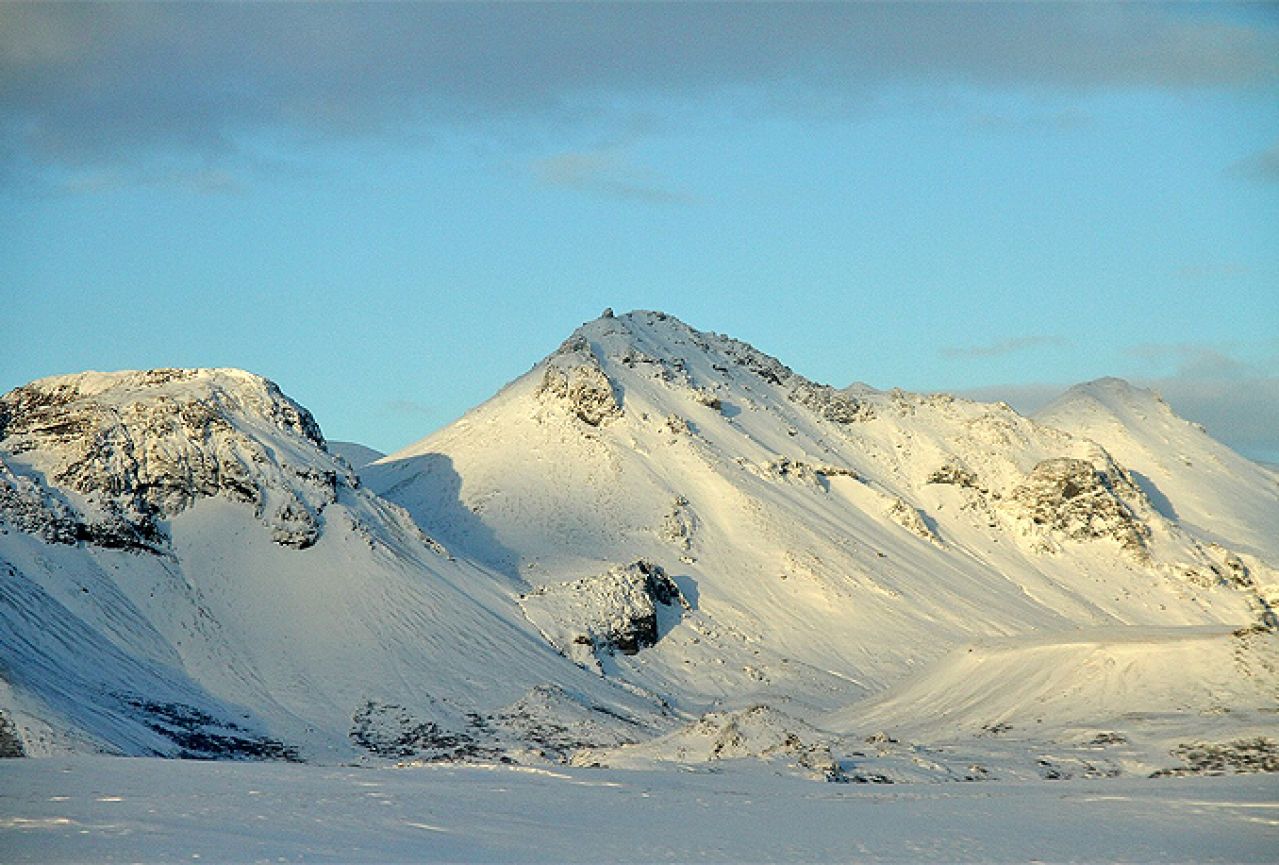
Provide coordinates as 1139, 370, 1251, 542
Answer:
0, 370, 663, 760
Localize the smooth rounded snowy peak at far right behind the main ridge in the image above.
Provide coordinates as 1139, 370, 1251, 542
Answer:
1035, 379, 1279, 566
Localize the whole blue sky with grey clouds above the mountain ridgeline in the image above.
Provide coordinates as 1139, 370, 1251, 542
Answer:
0, 4, 1279, 462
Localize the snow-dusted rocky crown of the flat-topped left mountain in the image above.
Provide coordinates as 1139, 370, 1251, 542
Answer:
0, 370, 358, 552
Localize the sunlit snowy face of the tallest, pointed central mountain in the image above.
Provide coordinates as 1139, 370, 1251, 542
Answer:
363, 312, 1266, 714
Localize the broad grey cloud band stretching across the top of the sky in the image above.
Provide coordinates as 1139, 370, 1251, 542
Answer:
0, 3, 1279, 182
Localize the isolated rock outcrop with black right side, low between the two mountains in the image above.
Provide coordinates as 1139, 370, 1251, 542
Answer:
519, 560, 688, 665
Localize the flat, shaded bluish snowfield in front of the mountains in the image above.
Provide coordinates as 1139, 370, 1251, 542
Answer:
0, 756, 1279, 862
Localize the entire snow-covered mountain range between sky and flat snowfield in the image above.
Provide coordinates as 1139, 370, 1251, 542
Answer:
0, 312, 1279, 781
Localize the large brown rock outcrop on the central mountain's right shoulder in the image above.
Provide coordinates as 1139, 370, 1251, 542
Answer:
1007, 457, 1150, 555
